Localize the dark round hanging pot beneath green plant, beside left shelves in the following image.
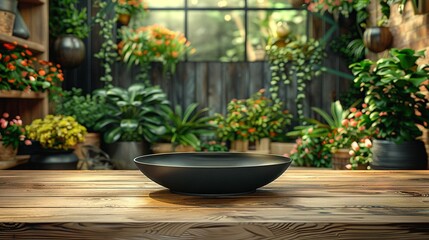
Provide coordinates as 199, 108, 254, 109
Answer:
54, 35, 85, 68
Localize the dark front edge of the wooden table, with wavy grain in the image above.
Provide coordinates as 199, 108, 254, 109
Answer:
0, 222, 429, 240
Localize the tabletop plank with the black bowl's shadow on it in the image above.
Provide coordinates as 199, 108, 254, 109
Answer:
0, 196, 429, 209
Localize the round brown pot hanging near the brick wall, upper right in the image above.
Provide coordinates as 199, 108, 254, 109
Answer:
363, 27, 393, 53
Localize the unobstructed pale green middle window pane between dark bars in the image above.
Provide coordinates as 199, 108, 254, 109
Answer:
188, 11, 245, 61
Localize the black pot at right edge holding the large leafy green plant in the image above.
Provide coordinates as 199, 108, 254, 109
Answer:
371, 140, 428, 170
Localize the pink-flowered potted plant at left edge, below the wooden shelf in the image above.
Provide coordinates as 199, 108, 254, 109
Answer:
0, 112, 31, 161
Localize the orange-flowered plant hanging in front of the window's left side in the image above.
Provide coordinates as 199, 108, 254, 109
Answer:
118, 25, 195, 73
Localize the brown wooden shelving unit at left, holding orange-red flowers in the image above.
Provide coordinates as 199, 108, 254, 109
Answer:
0, 0, 49, 124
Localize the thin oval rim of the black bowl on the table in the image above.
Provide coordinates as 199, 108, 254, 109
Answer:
133, 152, 292, 169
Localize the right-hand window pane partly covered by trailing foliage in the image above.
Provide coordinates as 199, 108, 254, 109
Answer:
247, 10, 307, 61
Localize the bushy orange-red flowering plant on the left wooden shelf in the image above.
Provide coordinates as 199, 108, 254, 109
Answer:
0, 43, 64, 93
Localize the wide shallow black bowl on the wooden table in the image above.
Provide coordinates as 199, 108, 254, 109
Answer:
134, 152, 291, 195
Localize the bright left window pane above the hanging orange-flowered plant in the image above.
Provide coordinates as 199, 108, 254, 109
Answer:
144, 10, 185, 33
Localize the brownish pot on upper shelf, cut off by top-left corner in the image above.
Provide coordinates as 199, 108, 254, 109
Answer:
0, 0, 18, 36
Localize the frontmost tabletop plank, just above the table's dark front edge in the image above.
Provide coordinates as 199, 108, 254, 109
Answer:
0, 205, 429, 224
